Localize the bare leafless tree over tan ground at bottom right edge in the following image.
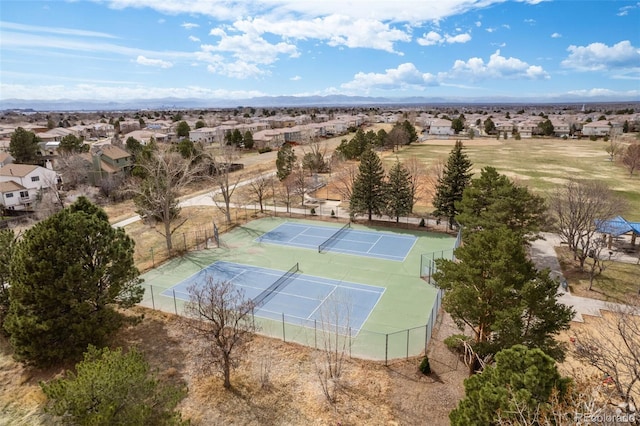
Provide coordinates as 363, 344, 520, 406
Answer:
573, 303, 640, 412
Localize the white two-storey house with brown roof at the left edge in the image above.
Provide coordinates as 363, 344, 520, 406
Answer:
0, 164, 59, 210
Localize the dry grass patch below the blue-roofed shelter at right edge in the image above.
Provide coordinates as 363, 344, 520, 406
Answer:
556, 246, 640, 303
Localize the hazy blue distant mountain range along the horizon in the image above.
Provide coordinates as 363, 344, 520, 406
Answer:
0, 95, 640, 111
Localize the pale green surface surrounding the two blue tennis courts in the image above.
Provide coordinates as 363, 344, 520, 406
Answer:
142, 218, 455, 359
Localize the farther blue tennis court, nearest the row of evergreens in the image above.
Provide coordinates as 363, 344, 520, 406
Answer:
256, 222, 417, 262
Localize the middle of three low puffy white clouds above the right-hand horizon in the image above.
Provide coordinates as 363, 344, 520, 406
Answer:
448, 50, 549, 80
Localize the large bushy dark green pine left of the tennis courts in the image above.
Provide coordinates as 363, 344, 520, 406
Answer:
4, 197, 144, 365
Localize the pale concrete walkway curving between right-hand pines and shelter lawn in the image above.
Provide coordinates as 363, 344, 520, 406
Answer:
530, 233, 635, 322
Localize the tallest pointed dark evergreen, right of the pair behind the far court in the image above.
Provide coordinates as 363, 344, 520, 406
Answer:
433, 141, 473, 229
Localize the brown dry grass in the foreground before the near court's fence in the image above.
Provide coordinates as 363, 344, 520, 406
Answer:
0, 308, 466, 425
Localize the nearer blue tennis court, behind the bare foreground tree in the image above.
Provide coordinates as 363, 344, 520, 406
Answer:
161, 261, 385, 336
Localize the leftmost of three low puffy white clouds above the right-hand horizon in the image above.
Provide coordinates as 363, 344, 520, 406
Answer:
340, 62, 438, 93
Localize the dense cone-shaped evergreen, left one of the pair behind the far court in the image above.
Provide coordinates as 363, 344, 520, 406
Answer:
349, 149, 386, 220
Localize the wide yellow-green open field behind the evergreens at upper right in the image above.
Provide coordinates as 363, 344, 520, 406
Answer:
385, 138, 640, 221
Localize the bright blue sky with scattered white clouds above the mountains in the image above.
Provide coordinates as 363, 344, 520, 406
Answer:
0, 0, 640, 102
